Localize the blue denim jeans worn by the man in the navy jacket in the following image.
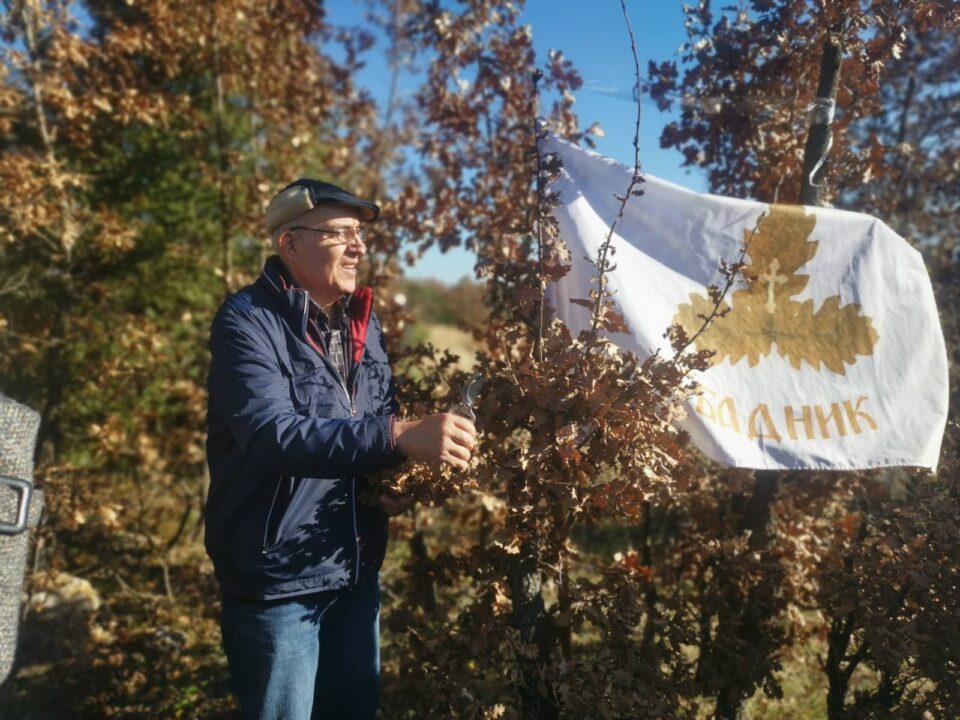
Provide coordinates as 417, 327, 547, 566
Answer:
220, 576, 380, 720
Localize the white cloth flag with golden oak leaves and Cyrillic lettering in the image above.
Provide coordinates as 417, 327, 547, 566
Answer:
546, 136, 947, 470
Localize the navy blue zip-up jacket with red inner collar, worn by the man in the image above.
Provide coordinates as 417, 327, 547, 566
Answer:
204, 257, 402, 600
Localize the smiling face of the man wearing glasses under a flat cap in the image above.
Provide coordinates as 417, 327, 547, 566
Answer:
278, 205, 367, 308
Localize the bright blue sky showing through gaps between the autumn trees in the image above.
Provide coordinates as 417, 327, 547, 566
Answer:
327, 0, 706, 282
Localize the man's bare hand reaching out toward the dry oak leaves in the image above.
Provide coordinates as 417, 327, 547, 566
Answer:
396, 413, 477, 470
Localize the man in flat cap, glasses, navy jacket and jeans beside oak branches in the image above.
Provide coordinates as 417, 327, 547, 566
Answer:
205, 179, 476, 720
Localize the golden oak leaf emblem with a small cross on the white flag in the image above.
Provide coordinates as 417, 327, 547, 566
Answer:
673, 205, 879, 375
